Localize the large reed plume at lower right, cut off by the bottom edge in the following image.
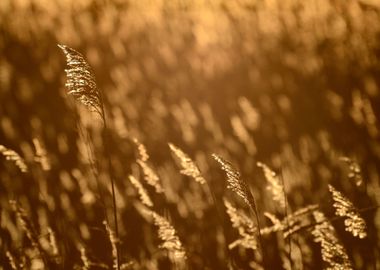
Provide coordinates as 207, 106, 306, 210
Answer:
312, 210, 353, 270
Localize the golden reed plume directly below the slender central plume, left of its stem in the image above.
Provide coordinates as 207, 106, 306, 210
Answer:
224, 199, 258, 250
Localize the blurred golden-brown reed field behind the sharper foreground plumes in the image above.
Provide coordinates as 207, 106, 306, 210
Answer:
0, 0, 380, 269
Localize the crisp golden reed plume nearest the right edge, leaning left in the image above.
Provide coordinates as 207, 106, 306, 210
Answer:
329, 185, 367, 239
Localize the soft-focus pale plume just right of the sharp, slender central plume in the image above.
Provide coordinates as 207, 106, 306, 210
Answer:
257, 162, 285, 208
